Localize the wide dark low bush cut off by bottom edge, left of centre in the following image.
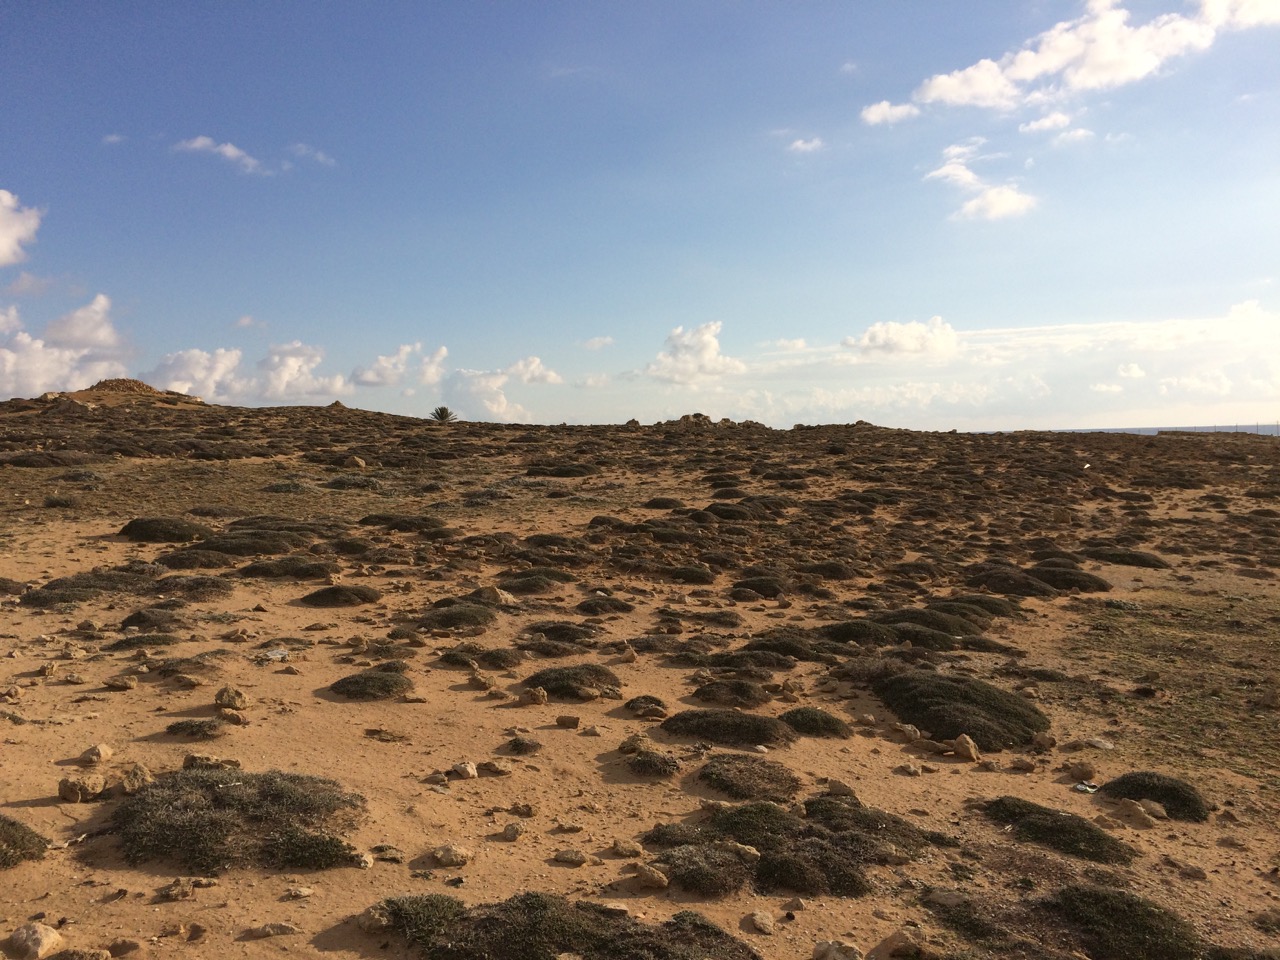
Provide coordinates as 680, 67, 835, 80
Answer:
375, 893, 760, 960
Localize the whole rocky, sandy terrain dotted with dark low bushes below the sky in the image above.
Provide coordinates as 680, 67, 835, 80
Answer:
0, 381, 1280, 960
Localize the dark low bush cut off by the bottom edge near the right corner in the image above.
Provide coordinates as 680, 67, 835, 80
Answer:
1047, 886, 1203, 960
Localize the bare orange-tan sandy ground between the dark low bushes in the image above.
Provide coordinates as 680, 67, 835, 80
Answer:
0, 386, 1280, 960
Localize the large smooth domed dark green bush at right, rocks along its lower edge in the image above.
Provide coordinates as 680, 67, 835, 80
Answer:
872, 669, 1048, 750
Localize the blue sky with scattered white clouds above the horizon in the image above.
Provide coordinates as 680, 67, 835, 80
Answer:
0, 0, 1280, 429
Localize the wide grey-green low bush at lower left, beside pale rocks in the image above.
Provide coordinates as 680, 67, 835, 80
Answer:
111, 769, 365, 874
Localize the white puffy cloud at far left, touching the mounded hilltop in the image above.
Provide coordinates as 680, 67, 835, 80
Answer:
0, 294, 125, 397
